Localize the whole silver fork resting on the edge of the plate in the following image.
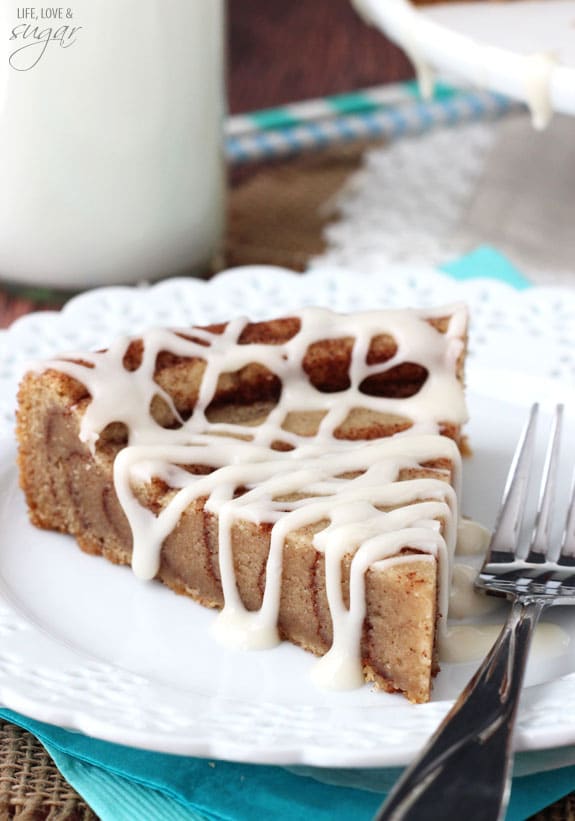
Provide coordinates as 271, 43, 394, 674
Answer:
376, 405, 575, 821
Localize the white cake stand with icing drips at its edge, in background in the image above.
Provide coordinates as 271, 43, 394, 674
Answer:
352, 0, 575, 128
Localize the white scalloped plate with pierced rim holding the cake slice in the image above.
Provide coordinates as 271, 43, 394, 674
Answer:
0, 267, 575, 767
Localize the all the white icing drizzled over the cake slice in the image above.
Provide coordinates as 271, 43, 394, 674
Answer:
40, 305, 467, 688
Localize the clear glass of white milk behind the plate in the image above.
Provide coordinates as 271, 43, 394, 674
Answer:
0, 0, 224, 289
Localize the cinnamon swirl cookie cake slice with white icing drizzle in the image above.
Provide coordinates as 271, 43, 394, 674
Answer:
18, 306, 467, 702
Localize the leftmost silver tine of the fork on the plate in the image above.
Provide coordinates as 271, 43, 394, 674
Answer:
485, 404, 539, 564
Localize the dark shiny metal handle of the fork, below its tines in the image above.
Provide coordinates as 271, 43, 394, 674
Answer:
375, 599, 545, 821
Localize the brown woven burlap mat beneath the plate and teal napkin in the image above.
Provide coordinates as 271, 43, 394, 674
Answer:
0, 146, 575, 821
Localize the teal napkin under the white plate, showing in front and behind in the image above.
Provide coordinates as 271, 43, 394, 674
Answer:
5, 246, 575, 821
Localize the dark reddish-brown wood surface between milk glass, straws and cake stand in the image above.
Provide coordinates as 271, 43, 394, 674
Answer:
228, 0, 411, 113
